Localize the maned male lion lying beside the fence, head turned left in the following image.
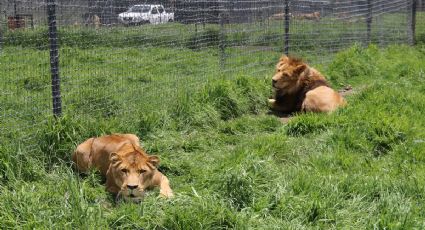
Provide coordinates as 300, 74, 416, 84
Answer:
269, 56, 346, 113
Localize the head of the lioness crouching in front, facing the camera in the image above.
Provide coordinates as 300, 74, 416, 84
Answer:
108, 146, 159, 201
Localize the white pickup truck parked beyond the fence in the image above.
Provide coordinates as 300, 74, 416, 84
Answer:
118, 5, 174, 25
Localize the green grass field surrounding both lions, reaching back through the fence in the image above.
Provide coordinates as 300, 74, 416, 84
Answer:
0, 41, 425, 229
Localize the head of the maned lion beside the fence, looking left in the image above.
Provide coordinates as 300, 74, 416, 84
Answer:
272, 56, 307, 93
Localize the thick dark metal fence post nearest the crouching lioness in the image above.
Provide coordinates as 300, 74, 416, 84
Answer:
47, 0, 62, 117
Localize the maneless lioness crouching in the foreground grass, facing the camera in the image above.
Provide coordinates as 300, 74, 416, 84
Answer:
72, 134, 173, 201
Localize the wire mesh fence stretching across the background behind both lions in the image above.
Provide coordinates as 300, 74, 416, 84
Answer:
0, 0, 425, 151
